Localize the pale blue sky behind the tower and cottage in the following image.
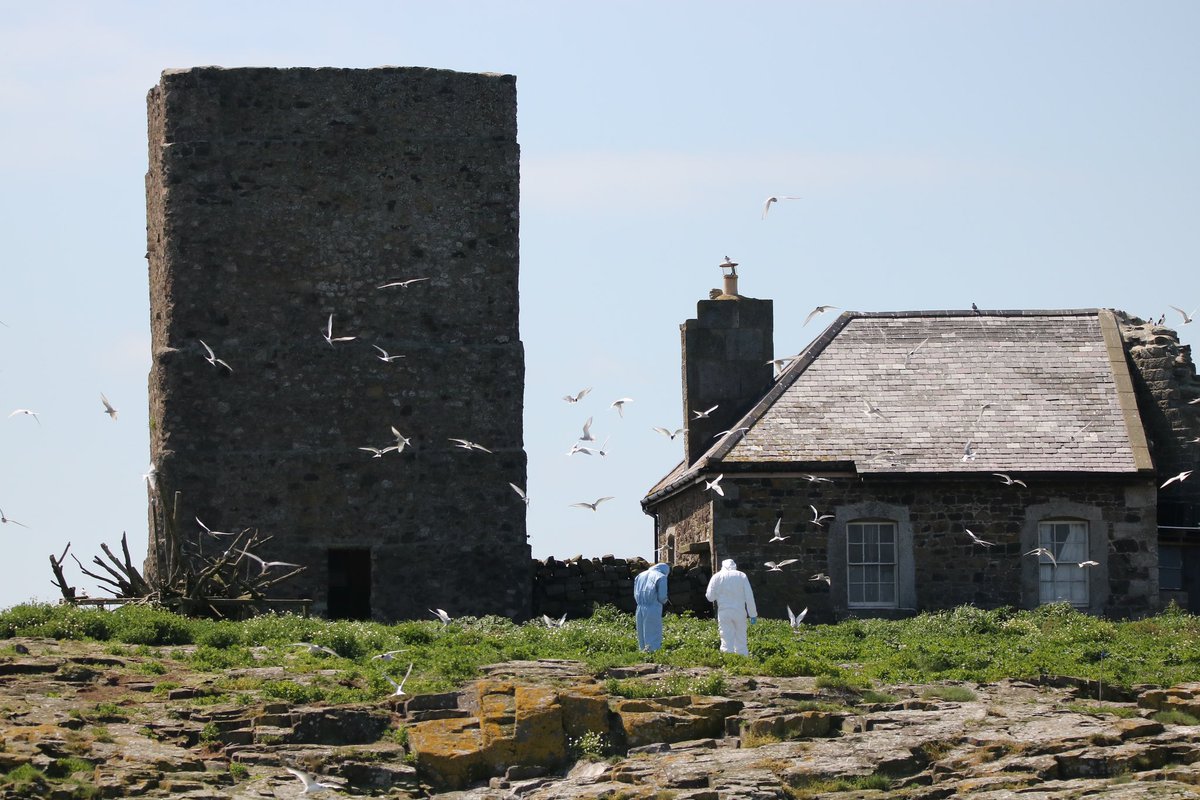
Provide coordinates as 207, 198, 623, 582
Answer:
0, 0, 1200, 608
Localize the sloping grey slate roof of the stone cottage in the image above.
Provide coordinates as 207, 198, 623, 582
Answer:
648, 309, 1152, 499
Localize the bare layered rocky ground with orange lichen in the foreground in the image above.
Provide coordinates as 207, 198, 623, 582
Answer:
0, 639, 1200, 800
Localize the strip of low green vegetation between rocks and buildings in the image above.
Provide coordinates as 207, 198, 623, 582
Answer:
0, 603, 1200, 703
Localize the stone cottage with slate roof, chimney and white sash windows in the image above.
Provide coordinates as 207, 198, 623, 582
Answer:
642, 266, 1200, 621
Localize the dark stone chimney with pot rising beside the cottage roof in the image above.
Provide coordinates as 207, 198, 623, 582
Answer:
679, 257, 774, 464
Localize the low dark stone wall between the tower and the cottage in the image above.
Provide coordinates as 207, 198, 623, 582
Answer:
533, 555, 713, 619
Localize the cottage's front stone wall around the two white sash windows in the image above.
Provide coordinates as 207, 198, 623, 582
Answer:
673, 473, 1158, 621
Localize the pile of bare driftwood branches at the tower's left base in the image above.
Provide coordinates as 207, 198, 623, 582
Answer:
50, 528, 307, 616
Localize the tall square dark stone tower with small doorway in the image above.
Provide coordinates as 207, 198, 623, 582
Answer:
146, 67, 530, 619
